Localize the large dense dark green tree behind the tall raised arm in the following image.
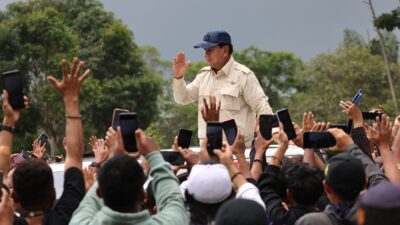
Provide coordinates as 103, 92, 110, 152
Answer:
0, 0, 162, 154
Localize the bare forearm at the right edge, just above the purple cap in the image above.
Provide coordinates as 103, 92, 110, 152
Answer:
379, 145, 400, 182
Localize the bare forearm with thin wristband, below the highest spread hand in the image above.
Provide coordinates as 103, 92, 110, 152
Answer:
64, 99, 83, 169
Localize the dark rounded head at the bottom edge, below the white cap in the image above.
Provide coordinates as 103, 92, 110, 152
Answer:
215, 199, 268, 225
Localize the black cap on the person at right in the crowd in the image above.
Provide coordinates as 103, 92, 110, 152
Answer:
325, 152, 365, 194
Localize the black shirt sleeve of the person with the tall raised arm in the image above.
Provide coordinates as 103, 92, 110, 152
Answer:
14, 167, 85, 225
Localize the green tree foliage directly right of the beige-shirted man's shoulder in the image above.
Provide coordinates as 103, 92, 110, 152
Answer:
234, 47, 303, 109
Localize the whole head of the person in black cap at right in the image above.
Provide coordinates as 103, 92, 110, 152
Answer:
324, 152, 366, 202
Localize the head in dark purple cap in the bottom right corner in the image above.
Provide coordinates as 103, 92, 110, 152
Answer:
357, 182, 400, 225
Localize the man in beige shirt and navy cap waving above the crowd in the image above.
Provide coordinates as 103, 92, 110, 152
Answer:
172, 31, 272, 147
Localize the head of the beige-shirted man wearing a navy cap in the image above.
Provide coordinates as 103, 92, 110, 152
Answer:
194, 30, 233, 70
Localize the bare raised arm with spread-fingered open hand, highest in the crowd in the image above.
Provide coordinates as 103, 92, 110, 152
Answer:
47, 58, 90, 170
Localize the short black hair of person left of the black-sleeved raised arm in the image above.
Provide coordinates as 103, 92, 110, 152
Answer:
13, 159, 54, 210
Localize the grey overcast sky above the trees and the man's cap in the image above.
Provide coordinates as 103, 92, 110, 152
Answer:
0, 0, 400, 61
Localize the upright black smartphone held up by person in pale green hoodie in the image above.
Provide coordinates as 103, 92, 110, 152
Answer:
119, 112, 138, 152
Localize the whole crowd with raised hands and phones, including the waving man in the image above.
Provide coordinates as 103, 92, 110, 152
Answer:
0, 31, 400, 225
